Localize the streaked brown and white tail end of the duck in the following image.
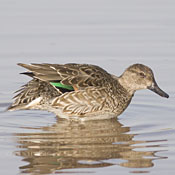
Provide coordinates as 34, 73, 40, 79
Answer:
7, 78, 61, 111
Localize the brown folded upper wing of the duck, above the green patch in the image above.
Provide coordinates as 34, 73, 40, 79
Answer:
18, 63, 113, 90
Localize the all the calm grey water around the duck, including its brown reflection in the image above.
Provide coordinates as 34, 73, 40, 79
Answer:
0, 0, 175, 175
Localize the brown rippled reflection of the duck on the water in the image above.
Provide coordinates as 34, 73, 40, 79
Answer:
15, 119, 165, 174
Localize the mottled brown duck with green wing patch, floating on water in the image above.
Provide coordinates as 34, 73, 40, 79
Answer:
8, 63, 169, 120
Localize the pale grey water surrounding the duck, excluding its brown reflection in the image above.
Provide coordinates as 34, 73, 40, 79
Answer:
0, 0, 175, 175
